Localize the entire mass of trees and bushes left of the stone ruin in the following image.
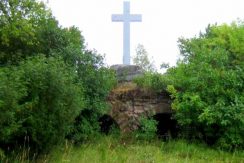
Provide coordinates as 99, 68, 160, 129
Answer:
0, 0, 116, 156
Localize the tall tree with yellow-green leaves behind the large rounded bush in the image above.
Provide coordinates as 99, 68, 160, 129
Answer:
0, 0, 84, 66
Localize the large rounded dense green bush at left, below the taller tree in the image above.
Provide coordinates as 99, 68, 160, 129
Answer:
0, 56, 84, 151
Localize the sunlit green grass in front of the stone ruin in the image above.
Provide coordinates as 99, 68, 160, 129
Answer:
38, 136, 244, 163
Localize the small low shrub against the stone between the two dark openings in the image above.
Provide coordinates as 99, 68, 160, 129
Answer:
136, 116, 157, 141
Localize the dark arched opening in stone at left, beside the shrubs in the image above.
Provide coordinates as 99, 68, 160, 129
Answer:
99, 114, 119, 134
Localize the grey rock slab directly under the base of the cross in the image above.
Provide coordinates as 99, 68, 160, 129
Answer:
110, 65, 143, 82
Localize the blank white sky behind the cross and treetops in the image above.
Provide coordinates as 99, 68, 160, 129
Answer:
44, 0, 244, 67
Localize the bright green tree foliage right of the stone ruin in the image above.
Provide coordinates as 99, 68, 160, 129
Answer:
167, 22, 244, 149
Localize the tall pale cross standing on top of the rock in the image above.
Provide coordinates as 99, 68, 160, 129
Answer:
112, 1, 142, 65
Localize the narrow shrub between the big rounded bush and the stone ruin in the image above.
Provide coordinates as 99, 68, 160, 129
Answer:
68, 51, 117, 143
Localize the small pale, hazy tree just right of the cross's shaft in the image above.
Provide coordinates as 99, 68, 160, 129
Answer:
133, 44, 155, 71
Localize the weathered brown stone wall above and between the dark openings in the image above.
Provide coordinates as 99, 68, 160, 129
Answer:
108, 82, 172, 132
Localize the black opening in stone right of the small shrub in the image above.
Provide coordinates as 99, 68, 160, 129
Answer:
153, 113, 177, 140
